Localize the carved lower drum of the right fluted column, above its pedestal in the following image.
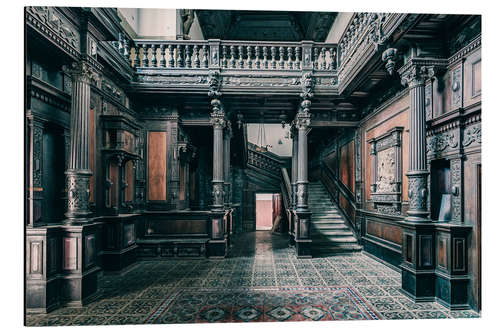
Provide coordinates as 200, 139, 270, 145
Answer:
405, 170, 431, 223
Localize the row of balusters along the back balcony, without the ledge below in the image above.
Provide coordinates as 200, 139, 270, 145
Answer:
114, 39, 337, 71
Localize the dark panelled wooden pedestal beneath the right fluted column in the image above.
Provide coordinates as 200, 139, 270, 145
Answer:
401, 222, 471, 309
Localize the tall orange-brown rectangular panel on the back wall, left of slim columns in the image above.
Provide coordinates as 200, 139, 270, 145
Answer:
148, 131, 167, 201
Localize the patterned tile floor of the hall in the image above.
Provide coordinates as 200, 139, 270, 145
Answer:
26, 232, 478, 326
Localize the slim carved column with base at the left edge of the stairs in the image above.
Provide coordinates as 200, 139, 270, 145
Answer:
295, 73, 314, 258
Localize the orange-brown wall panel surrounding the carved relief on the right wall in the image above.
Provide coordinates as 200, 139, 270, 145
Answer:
363, 95, 410, 201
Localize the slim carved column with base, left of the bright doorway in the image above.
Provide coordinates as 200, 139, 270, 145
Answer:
207, 71, 227, 257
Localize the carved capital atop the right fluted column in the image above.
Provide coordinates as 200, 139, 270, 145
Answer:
398, 58, 446, 89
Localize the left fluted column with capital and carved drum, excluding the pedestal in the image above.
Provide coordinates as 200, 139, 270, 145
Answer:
64, 61, 97, 224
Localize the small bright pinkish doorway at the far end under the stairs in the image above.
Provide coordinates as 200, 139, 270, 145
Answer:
255, 193, 281, 231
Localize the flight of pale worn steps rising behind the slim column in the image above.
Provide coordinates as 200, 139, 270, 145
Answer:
309, 182, 362, 255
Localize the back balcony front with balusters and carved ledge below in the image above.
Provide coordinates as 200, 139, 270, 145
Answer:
115, 39, 338, 95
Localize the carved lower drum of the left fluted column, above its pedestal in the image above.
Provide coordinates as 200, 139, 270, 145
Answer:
65, 169, 92, 224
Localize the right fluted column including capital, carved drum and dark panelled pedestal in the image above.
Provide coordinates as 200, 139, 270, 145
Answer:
399, 58, 436, 301
